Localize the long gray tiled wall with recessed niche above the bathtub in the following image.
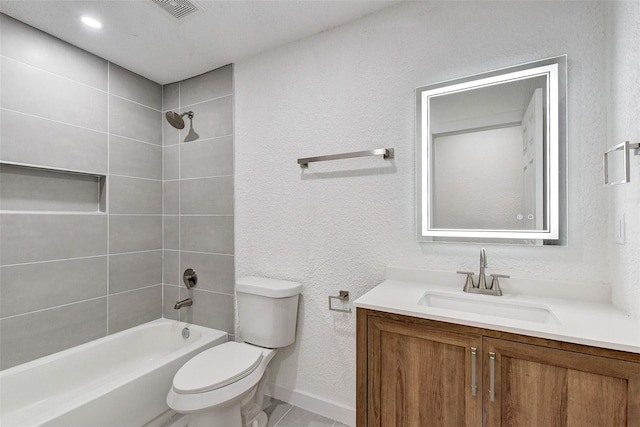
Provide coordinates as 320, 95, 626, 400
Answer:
0, 15, 163, 369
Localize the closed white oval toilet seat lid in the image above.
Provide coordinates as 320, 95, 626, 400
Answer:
173, 341, 262, 394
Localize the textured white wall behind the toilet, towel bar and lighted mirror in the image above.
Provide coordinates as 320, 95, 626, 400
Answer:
235, 1, 608, 422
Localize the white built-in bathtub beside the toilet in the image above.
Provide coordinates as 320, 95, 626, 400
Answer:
0, 319, 227, 427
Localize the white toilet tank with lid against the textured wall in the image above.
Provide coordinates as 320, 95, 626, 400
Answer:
236, 276, 302, 348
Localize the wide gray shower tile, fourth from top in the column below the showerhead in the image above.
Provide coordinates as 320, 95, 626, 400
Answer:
180, 176, 233, 215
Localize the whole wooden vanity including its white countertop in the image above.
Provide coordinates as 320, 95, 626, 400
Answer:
354, 267, 640, 427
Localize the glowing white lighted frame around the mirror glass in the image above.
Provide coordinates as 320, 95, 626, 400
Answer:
416, 55, 567, 245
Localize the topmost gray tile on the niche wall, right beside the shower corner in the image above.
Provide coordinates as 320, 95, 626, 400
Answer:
109, 62, 162, 110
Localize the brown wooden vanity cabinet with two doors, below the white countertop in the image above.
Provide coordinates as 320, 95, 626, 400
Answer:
356, 308, 640, 427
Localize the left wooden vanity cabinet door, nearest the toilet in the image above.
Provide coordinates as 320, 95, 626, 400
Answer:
367, 317, 482, 427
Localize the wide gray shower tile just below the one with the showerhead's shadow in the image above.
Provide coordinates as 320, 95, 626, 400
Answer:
180, 136, 233, 178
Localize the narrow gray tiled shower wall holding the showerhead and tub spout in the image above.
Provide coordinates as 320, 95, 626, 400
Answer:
162, 65, 235, 333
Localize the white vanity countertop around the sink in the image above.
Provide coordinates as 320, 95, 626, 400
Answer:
354, 277, 640, 354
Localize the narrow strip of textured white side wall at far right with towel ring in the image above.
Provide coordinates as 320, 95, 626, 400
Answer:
603, 1, 640, 316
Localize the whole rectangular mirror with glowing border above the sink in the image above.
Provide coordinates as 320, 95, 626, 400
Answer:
416, 56, 566, 245
